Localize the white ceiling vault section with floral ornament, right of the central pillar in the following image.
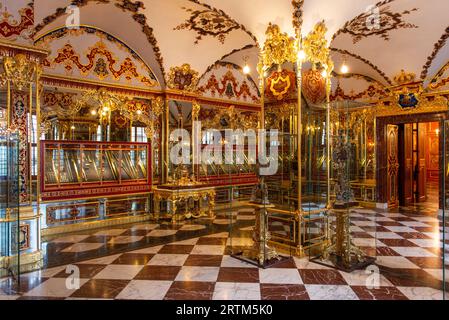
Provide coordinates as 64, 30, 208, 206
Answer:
331, 0, 449, 84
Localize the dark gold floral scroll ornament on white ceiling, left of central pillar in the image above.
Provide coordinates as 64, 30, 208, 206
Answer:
173, 7, 240, 44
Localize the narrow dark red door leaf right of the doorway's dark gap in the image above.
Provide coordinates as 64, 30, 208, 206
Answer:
402, 123, 413, 205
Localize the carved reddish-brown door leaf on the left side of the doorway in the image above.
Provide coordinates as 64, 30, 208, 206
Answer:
387, 124, 399, 207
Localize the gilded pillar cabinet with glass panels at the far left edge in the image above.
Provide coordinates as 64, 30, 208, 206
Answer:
0, 41, 46, 279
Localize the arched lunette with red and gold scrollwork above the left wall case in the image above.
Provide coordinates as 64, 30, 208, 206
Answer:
34, 26, 160, 90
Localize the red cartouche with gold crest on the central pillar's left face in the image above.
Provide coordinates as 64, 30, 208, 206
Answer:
265, 69, 296, 100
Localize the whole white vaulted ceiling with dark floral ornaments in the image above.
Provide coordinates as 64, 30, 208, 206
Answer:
34, 0, 449, 90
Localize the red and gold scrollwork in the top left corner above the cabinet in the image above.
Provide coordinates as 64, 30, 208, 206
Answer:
0, 4, 34, 40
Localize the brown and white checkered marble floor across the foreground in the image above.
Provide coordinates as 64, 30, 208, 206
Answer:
0, 209, 449, 300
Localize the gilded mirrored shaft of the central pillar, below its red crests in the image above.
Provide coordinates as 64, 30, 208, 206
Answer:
266, 101, 329, 255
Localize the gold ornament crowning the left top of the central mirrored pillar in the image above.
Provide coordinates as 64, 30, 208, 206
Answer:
262, 23, 297, 67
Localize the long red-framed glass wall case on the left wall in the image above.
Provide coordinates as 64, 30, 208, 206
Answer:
41, 140, 151, 201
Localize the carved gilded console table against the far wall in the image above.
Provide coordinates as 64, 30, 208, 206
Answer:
154, 185, 215, 223
